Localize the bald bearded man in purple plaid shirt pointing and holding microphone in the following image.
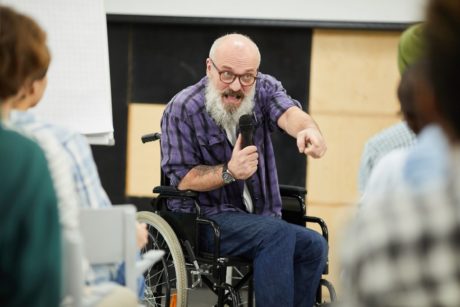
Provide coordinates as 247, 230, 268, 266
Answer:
161, 34, 327, 307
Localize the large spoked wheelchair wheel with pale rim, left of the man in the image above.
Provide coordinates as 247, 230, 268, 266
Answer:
137, 211, 188, 307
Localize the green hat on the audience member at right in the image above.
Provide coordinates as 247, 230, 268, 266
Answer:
398, 24, 425, 75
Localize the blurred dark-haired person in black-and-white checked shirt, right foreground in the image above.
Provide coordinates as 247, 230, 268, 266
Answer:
342, 0, 460, 307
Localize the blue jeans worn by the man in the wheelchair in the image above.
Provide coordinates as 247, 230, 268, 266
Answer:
200, 212, 328, 307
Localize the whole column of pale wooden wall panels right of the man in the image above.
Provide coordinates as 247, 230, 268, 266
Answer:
306, 30, 400, 294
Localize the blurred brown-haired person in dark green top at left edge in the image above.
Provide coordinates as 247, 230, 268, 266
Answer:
0, 5, 61, 307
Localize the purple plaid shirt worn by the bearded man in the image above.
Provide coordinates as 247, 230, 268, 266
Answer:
161, 73, 300, 217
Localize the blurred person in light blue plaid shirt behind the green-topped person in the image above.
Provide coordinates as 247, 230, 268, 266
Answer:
2, 7, 147, 306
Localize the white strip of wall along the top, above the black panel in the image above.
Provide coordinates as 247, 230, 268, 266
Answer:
104, 0, 426, 23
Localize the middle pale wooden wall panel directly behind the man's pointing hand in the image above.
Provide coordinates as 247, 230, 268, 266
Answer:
307, 113, 399, 204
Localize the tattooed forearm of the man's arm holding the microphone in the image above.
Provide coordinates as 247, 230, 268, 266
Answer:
178, 164, 224, 192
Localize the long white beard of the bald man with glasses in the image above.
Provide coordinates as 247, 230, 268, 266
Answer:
205, 82, 256, 130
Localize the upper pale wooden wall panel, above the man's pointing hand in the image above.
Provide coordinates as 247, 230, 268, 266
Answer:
310, 30, 399, 115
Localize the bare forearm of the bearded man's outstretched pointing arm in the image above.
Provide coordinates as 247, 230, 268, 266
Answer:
278, 107, 319, 138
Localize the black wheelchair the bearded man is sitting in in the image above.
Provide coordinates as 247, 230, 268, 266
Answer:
137, 133, 336, 307
